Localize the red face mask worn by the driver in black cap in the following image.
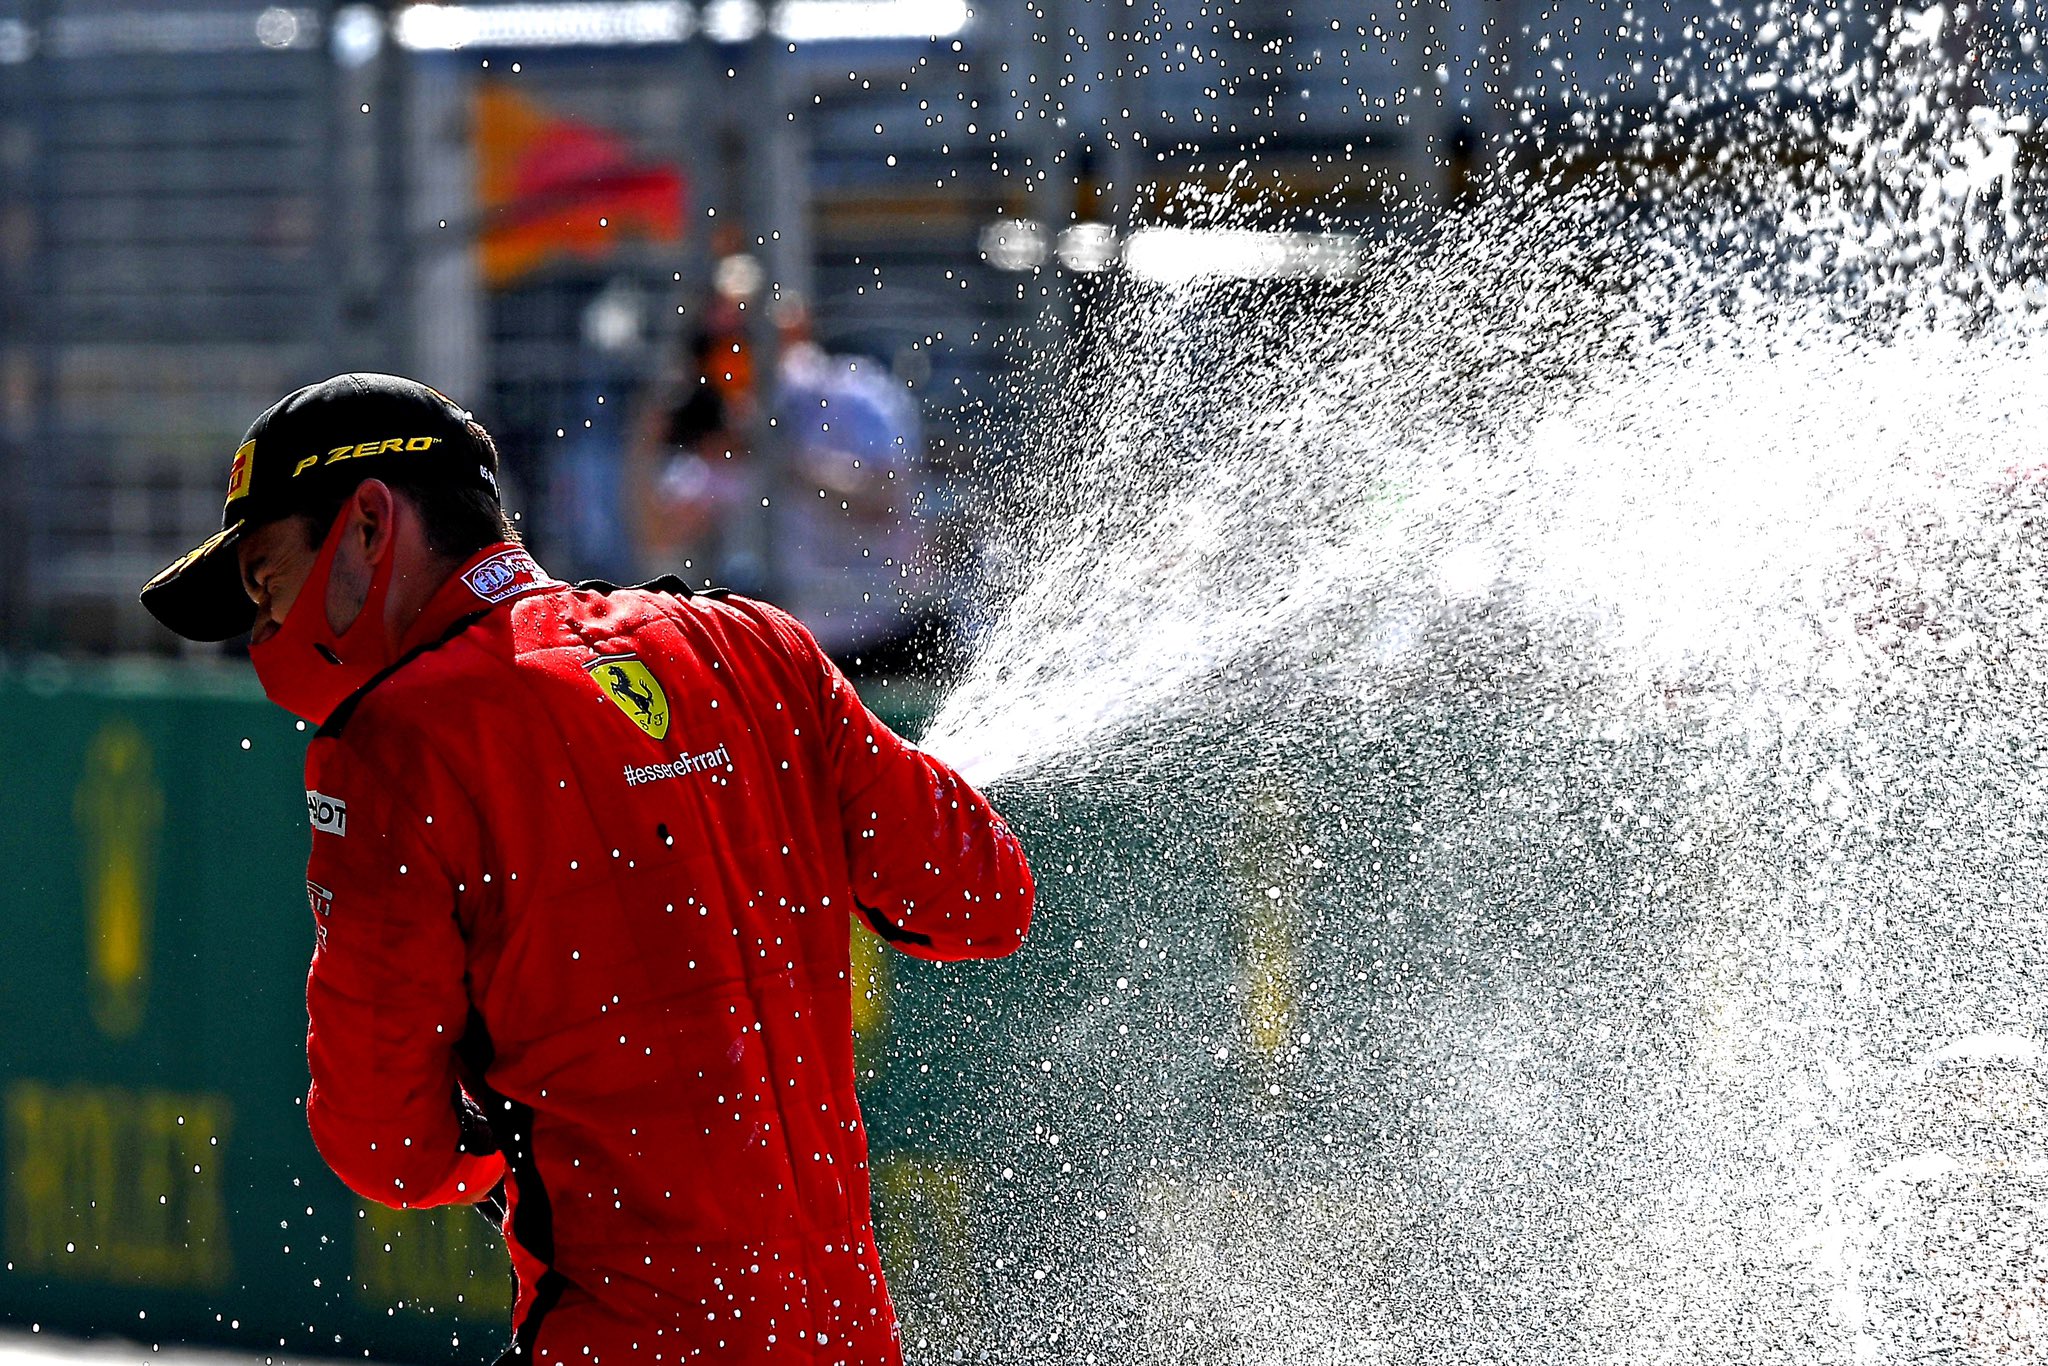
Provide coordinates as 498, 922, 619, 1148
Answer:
250, 508, 397, 725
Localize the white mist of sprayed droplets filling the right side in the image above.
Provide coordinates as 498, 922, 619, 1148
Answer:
909, 10, 2048, 1364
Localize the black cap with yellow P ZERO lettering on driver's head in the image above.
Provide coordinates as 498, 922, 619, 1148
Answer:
141, 375, 498, 641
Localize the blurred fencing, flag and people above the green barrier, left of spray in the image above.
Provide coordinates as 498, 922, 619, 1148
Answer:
0, 0, 2034, 672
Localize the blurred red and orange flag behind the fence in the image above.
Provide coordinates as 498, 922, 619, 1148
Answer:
471, 82, 684, 289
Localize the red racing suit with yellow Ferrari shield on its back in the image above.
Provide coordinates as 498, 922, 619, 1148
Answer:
305, 547, 1032, 1366
